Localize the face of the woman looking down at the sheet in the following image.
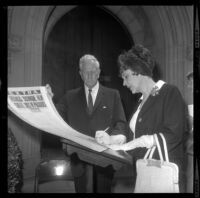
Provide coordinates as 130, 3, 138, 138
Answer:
122, 69, 140, 94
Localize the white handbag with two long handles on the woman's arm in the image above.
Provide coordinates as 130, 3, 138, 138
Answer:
134, 133, 179, 193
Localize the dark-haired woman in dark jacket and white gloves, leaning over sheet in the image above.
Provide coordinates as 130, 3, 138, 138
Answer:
110, 45, 186, 192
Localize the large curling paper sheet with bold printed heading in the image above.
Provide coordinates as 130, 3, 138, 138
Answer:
8, 86, 107, 152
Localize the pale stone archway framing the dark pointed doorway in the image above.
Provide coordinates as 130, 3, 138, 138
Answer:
8, 6, 193, 177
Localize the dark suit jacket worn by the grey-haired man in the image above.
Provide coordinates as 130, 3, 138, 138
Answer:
56, 85, 126, 137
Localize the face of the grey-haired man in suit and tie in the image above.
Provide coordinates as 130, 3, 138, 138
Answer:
80, 60, 100, 88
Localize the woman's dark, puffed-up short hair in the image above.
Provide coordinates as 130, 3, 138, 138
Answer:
118, 45, 155, 77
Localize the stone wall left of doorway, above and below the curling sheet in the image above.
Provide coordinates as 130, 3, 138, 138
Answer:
8, 6, 51, 178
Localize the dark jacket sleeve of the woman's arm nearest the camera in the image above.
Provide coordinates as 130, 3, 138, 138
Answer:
158, 86, 187, 151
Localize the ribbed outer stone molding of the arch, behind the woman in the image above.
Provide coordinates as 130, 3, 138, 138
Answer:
143, 6, 193, 98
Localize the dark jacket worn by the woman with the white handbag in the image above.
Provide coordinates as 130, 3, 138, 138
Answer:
128, 84, 187, 169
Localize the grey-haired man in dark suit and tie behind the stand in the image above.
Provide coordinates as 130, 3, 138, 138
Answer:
46, 55, 126, 193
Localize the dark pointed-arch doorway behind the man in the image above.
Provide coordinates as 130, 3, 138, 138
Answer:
43, 6, 136, 149
